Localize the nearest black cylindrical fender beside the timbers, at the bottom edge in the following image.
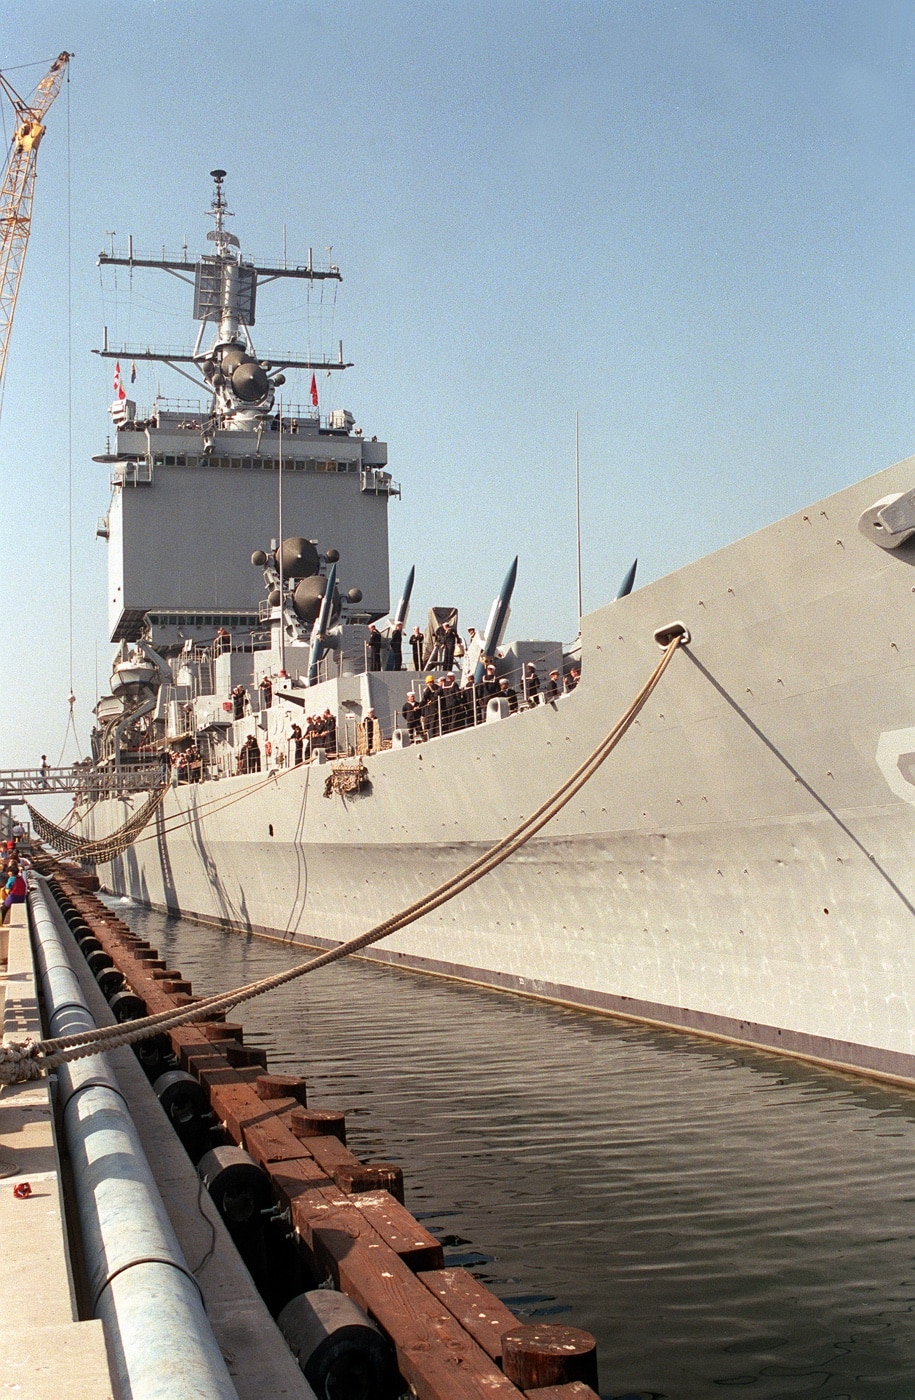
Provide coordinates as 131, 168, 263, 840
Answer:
277, 1288, 402, 1400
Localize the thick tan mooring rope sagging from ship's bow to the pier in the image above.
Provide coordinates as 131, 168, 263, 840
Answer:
0, 636, 686, 1084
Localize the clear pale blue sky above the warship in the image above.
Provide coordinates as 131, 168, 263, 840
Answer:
0, 0, 915, 767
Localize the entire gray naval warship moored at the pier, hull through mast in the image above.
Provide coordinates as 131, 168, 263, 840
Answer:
52, 171, 915, 1081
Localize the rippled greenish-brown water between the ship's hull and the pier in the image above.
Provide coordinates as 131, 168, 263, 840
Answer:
122, 909, 915, 1400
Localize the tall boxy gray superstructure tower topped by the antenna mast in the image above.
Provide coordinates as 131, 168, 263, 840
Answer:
97, 171, 397, 651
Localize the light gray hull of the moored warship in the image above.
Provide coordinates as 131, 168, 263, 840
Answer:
89, 459, 915, 1079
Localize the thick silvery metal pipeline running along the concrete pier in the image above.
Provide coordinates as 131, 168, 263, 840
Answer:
31, 881, 238, 1400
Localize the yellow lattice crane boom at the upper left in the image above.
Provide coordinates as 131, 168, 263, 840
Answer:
0, 52, 73, 395
